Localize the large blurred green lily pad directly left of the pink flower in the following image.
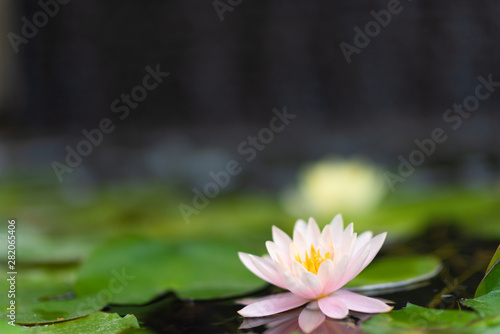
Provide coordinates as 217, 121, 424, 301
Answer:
74, 237, 264, 304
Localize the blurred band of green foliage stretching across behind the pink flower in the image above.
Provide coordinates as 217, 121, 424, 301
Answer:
0, 179, 500, 263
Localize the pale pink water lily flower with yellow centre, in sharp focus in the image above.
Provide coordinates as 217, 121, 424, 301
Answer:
238, 215, 392, 332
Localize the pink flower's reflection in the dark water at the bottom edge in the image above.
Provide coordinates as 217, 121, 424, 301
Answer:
240, 307, 362, 334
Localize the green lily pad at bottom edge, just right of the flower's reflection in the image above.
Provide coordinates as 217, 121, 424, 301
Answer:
362, 304, 479, 334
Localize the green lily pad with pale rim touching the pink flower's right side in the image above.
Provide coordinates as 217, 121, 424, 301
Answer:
346, 255, 441, 291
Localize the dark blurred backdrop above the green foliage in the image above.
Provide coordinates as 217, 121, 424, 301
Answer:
0, 0, 500, 189
